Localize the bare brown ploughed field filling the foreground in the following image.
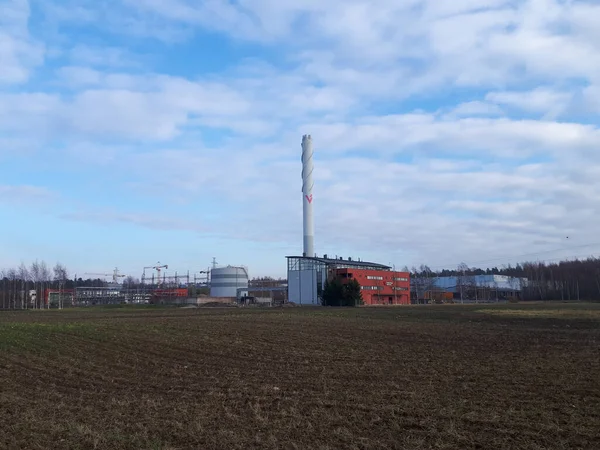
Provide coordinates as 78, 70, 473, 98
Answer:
0, 304, 600, 449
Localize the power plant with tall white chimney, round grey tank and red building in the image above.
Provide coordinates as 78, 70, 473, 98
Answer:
37, 134, 410, 306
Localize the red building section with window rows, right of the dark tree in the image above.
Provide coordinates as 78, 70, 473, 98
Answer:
329, 268, 410, 305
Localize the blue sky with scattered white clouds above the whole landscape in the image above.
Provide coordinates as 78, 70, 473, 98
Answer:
0, 0, 600, 277
